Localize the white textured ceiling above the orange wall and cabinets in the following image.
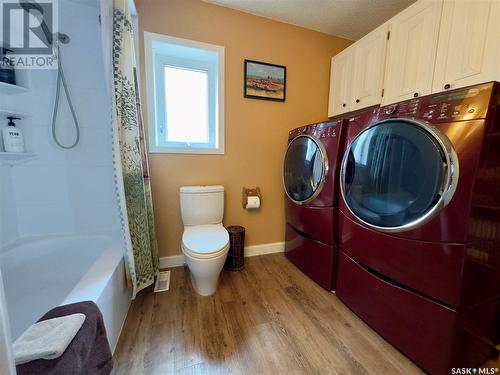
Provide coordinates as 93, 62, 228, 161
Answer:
204, 0, 415, 40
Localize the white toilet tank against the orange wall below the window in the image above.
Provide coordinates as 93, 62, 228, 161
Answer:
180, 185, 224, 225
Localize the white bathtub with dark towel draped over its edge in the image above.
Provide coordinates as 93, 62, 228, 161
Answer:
0, 235, 131, 351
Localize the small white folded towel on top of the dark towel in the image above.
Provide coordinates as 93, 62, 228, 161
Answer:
13, 314, 85, 365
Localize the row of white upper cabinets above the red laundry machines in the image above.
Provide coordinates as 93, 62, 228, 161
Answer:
328, 0, 500, 117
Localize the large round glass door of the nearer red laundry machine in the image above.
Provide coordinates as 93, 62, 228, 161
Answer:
340, 119, 458, 232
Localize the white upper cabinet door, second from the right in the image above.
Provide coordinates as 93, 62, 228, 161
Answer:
382, 0, 443, 104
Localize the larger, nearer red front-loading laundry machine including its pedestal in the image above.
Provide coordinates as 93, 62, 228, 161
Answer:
337, 83, 500, 374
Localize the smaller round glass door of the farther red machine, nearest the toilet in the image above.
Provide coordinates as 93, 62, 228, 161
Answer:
283, 135, 328, 204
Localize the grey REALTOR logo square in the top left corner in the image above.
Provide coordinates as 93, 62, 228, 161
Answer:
0, 0, 58, 69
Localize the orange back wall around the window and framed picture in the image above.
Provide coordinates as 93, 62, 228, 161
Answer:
135, 0, 352, 256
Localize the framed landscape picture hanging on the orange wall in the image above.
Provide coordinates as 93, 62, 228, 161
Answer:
244, 60, 286, 102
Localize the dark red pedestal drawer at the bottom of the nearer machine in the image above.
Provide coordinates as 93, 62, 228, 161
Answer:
336, 251, 492, 374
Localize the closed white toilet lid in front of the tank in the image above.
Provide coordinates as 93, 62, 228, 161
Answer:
182, 224, 229, 257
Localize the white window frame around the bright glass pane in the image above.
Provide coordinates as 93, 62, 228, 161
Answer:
144, 32, 224, 155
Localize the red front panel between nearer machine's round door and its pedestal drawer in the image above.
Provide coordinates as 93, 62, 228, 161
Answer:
339, 211, 464, 306
